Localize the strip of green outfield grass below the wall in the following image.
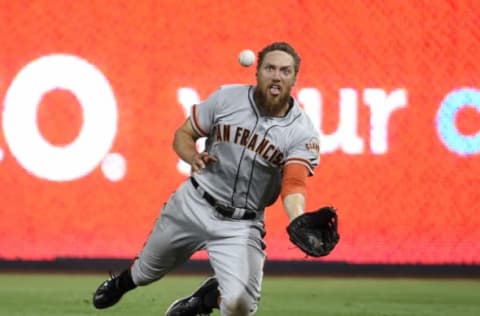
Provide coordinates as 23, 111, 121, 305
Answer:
0, 273, 480, 316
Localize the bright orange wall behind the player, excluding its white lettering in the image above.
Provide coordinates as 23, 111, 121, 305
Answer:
0, 0, 480, 264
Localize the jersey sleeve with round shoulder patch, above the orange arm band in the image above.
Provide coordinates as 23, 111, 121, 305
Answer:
285, 132, 320, 176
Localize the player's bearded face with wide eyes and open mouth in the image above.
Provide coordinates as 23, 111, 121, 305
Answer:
255, 50, 296, 116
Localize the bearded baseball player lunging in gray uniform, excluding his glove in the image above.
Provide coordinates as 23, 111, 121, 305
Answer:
93, 42, 319, 316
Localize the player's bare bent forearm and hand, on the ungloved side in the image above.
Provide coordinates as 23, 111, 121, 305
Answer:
173, 119, 217, 173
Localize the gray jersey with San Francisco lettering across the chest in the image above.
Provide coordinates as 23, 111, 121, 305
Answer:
190, 85, 319, 210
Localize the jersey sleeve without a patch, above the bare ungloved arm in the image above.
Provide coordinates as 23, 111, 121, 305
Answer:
190, 90, 220, 137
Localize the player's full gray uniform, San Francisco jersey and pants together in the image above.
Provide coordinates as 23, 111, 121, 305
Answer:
131, 85, 319, 316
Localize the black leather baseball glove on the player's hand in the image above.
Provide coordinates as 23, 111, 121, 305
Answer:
287, 206, 340, 257
